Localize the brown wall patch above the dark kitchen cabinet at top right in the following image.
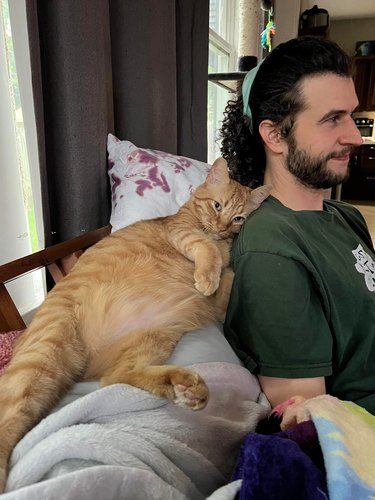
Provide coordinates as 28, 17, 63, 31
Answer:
329, 18, 375, 56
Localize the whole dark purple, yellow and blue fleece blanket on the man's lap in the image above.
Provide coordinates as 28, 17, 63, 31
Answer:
219, 395, 375, 500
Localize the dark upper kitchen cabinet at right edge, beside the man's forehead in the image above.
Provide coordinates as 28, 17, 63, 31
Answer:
354, 56, 375, 111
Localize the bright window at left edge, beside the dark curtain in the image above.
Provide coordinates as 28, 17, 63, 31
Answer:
0, 0, 45, 322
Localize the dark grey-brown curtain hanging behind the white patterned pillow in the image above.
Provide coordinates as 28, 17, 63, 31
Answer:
26, 0, 209, 246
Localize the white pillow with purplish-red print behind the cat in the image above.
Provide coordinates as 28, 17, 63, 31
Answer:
107, 134, 210, 231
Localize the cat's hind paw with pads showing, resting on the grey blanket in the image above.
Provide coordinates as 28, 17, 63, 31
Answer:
172, 370, 209, 410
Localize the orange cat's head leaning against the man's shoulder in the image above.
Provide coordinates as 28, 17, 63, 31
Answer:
192, 158, 272, 239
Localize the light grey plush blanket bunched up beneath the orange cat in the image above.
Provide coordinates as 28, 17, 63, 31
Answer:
2, 362, 269, 500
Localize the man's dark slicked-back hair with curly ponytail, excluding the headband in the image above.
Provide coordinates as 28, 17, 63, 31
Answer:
220, 36, 352, 187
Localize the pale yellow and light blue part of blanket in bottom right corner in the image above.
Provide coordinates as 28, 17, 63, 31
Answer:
280, 395, 375, 500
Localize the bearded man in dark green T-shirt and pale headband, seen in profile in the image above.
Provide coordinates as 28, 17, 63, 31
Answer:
222, 37, 375, 414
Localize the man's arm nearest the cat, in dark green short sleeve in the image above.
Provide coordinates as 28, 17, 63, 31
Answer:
225, 254, 333, 406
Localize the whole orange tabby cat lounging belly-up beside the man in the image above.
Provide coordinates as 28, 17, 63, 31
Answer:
0, 160, 270, 487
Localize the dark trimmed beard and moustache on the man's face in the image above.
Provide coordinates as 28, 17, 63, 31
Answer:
286, 135, 351, 189
